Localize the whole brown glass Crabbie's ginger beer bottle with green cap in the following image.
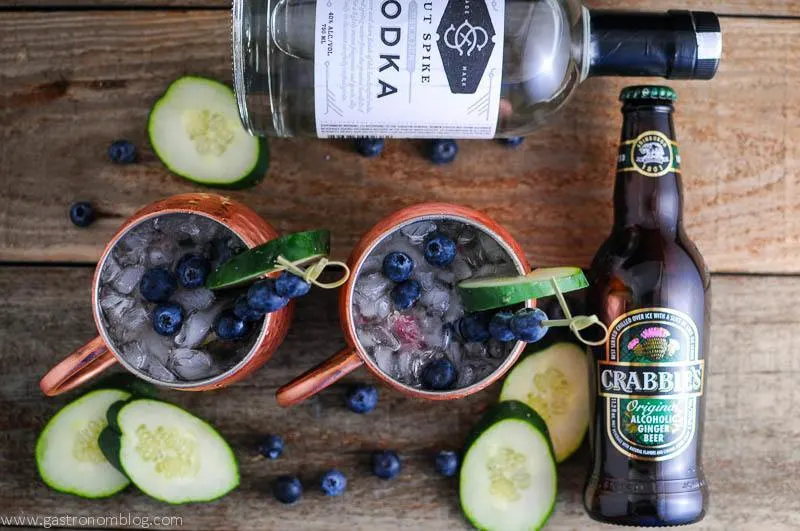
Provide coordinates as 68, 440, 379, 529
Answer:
584, 87, 710, 526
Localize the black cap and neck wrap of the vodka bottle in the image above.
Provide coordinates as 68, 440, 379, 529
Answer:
589, 10, 722, 79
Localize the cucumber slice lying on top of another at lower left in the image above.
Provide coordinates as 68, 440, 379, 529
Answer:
109, 398, 239, 504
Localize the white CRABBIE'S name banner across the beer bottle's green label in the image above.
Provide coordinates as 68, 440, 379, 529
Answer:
597, 360, 703, 397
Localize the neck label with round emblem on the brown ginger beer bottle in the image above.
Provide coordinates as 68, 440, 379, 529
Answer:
617, 131, 680, 177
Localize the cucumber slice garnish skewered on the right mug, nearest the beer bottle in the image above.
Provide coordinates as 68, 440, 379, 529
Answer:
458, 267, 589, 312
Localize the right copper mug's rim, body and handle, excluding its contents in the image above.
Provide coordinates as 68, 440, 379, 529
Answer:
276, 203, 535, 407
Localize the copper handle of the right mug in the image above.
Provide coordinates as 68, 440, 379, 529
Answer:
275, 347, 364, 407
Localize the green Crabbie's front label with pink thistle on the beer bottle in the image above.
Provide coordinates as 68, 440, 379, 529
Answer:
597, 308, 704, 461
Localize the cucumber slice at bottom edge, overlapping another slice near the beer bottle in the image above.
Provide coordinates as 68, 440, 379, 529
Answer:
459, 401, 557, 531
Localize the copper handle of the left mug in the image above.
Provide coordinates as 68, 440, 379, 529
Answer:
39, 336, 117, 396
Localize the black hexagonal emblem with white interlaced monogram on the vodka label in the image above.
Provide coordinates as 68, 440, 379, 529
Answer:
436, 0, 495, 94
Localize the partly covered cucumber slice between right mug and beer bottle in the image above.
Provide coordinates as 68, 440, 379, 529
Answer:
500, 343, 589, 463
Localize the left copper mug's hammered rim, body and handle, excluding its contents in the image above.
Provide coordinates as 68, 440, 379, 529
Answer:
39, 194, 294, 396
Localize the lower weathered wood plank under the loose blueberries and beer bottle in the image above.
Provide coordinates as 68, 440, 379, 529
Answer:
0, 268, 800, 531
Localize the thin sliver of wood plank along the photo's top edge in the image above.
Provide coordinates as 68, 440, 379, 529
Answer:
0, 0, 800, 16
